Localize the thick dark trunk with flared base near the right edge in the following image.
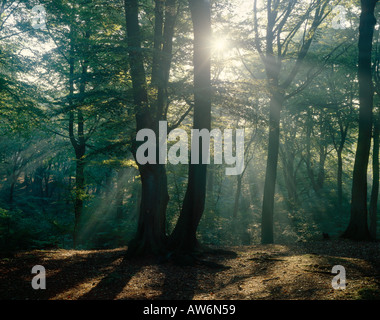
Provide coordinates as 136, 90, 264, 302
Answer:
342, 0, 377, 240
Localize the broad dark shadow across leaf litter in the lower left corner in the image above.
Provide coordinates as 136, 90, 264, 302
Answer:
0, 251, 128, 300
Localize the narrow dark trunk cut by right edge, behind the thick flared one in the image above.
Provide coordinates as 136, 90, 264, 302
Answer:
369, 109, 380, 239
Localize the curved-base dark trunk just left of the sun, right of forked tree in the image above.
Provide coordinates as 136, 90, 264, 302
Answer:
171, 0, 211, 252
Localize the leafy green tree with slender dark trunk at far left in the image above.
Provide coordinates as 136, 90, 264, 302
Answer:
31, 1, 129, 246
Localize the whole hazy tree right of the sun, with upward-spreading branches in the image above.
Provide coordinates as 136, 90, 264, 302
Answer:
254, 0, 328, 243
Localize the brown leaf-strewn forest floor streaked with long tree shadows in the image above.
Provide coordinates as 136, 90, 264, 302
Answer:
0, 240, 380, 300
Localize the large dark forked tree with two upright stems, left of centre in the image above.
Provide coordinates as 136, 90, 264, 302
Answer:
124, 0, 177, 255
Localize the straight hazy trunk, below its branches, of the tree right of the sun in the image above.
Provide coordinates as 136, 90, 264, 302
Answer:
261, 93, 284, 244
